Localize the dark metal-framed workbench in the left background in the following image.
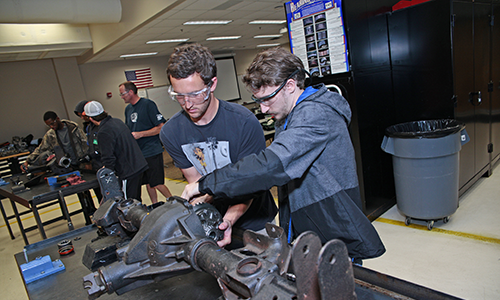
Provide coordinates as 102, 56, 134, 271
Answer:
0, 173, 99, 245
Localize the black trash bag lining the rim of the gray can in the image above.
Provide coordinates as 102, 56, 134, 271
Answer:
385, 119, 465, 139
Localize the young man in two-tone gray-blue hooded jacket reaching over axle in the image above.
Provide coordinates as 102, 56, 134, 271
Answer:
182, 47, 385, 261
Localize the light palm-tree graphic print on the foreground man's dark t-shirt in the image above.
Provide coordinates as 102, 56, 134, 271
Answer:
181, 137, 231, 176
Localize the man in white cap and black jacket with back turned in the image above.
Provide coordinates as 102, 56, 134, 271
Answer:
84, 101, 148, 201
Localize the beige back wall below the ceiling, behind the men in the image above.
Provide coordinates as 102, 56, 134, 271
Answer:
0, 50, 270, 143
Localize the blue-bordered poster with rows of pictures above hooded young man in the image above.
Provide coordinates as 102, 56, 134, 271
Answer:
285, 0, 349, 77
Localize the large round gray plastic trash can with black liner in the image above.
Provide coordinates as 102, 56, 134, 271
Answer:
381, 119, 469, 230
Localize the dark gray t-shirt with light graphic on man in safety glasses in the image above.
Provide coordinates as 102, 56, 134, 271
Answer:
160, 100, 277, 231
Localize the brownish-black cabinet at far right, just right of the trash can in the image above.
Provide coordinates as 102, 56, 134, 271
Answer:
452, 1, 494, 190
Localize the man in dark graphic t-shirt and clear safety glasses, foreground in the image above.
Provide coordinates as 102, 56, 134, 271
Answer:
160, 44, 277, 247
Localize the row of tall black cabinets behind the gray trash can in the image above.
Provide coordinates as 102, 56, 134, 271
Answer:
330, 0, 500, 216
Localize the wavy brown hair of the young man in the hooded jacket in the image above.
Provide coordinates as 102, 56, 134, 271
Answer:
243, 47, 306, 91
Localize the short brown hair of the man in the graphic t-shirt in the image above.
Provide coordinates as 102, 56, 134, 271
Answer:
166, 44, 217, 85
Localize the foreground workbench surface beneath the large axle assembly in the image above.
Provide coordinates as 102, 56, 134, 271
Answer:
14, 225, 458, 300
